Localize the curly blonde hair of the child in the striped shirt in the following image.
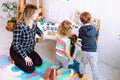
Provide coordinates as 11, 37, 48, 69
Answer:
58, 20, 72, 36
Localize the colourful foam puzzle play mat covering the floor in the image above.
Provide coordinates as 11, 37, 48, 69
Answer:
0, 55, 87, 80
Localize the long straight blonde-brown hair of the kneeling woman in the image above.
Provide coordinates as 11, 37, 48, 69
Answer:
19, 4, 37, 25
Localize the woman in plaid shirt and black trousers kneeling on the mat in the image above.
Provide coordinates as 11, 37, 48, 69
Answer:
10, 4, 44, 73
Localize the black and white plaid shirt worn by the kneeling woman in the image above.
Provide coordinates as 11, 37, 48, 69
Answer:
12, 22, 43, 58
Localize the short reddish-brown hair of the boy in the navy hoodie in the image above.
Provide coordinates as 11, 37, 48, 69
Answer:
80, 12, 91, 24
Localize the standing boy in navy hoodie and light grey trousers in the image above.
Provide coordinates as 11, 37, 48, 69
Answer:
78, 12, 98, 80
